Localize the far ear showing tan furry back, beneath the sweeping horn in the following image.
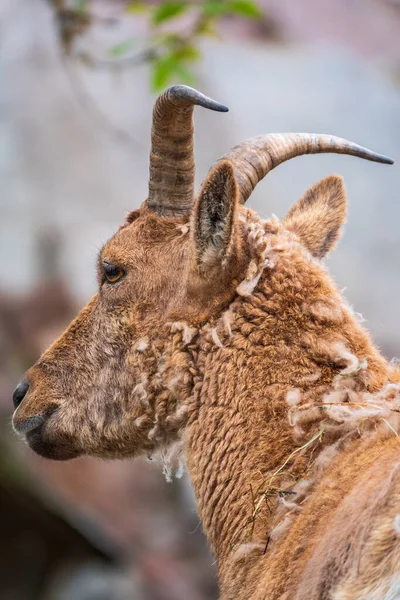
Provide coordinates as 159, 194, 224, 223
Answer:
283, 175, 347, 258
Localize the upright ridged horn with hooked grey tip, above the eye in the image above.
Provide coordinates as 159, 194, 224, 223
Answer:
146, 85, 229, 215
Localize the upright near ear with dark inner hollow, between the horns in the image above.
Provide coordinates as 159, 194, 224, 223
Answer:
191, 161, 238, 273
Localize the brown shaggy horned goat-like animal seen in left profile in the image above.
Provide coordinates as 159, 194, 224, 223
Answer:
13, 86, 400, 600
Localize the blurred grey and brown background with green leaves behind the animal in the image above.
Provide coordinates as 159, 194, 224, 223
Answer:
0, 0, 400, 600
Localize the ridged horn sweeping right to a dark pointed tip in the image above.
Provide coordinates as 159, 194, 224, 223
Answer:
219, 133, 393, 204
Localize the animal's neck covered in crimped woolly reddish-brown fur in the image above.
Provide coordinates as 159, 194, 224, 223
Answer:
185, 232, 390, 579
